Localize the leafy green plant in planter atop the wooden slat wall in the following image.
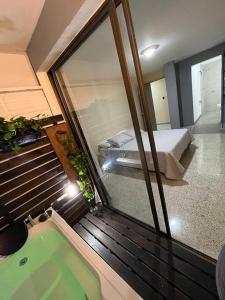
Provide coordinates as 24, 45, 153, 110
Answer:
0, 115, 44, 152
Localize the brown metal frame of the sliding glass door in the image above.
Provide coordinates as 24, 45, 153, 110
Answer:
48, 0, 171, 237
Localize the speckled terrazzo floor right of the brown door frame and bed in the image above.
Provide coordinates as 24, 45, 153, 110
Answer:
158, 129, 225, 259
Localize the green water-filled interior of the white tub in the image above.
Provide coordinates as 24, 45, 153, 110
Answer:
0, 228, 102, 300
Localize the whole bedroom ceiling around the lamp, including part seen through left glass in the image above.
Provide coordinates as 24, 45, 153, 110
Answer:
62, 0, 225, 81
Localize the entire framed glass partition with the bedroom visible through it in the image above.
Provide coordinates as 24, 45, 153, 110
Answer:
51, 0, 225, 258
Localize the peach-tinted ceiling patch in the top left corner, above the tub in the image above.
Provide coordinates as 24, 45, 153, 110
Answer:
0, 0, 45, 52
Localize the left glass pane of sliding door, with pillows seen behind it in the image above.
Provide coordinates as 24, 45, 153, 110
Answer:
57, 19, 156, 225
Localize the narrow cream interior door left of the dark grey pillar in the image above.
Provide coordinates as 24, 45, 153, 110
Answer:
151, 78, 170, 124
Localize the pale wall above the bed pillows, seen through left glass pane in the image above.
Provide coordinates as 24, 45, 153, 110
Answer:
64, 81, 133, 153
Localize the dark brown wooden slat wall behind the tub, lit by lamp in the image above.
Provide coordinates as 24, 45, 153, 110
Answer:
0, 123, 87, 231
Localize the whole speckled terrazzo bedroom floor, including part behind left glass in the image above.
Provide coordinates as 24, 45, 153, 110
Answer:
105, 113, 225, 258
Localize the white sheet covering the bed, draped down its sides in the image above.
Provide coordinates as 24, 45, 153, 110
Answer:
101, 128, 193, 179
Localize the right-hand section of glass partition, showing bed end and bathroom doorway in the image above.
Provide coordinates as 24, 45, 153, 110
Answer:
129, 0, 225, 259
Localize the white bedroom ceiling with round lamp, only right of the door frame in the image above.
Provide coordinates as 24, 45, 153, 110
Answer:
129, 0, 225, 78
